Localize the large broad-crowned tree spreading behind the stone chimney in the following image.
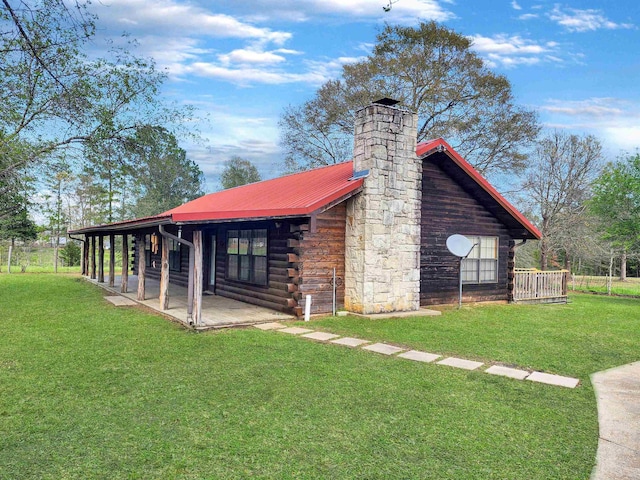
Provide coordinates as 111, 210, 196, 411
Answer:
279, 22, 539, 175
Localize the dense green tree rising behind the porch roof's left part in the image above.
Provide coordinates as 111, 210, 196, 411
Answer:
128, 125, 204, 217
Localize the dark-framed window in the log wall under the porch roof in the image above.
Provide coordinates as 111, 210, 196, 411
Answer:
227, 229, 267, 285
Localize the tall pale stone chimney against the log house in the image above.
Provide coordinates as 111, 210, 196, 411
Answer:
345, 99, 422, 314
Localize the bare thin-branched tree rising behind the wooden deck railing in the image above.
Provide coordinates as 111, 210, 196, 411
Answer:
524, 131, 602, 270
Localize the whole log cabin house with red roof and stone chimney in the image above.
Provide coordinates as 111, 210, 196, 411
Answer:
71, 99, 540, 325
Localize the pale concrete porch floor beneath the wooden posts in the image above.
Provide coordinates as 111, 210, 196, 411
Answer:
84, 275, 295, 330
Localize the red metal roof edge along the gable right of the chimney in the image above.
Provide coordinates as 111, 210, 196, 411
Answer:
416, 138, 542, 239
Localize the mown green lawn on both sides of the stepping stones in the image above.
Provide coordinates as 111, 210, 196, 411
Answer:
0, 274, 640, 479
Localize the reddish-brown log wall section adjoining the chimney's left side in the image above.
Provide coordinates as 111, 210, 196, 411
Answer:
299, 202, 347, 314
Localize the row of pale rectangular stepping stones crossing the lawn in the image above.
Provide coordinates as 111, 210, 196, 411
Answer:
254, 324, 580, 388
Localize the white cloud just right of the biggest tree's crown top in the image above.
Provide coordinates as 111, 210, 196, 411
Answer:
469, 34, 557, 67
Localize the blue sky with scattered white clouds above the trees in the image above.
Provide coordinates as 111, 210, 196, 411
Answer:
87, 0, 640, 191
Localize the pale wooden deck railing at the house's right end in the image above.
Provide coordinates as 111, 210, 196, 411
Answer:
513, 268, 568, 302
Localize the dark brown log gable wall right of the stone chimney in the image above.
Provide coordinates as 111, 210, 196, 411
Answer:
420, 161, 511, 305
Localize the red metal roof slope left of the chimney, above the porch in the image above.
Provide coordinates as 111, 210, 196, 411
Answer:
159, 162, 364, 222
